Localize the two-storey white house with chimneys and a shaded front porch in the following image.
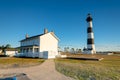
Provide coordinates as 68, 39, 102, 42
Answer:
20, 29, 58, 58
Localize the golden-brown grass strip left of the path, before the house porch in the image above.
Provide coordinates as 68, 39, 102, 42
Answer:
0, 57, 44, 69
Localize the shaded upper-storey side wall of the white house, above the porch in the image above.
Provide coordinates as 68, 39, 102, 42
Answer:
21, 37, 40, 46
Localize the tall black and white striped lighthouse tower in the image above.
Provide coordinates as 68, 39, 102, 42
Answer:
86, 14, 96, 54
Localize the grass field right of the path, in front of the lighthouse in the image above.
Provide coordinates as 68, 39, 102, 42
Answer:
55, 55, 120, 80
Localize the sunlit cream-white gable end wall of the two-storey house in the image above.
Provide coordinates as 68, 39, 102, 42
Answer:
40, 33, 58, 55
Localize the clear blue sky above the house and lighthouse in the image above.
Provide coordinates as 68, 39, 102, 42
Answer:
0, 0, 120, 51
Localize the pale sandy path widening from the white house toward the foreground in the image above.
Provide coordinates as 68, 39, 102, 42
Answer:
0, 60, 74, 80
